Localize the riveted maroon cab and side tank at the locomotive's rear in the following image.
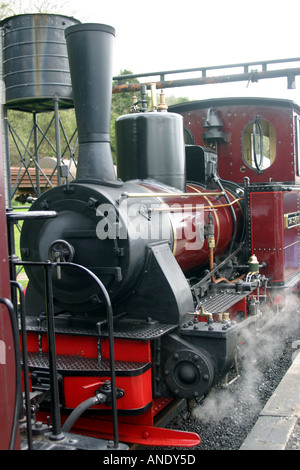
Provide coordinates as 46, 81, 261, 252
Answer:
171, 98, 300, 289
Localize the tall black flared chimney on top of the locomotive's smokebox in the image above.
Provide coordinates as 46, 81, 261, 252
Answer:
65, 23, 117, 183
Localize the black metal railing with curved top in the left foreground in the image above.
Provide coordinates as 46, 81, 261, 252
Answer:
6, 211, 119, 449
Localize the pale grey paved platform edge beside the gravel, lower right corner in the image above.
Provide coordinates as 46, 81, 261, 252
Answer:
240, 352, 300, 450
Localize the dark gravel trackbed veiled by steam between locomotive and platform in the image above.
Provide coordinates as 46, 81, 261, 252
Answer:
164, 309, 300, 450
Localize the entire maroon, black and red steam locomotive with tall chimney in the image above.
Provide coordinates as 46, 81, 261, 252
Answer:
2, 24, 300, 447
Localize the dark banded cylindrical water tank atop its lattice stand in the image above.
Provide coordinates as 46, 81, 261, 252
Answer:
0, 14, 79, 112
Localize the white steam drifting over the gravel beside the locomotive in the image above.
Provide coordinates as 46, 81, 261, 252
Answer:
192, 295, 300, 426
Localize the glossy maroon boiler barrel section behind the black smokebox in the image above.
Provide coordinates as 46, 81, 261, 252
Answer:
142, 183, 242, 272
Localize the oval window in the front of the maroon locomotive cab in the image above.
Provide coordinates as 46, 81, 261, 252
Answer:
243, 116, 276, 172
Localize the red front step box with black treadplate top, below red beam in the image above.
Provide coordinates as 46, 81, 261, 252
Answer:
28, 352, 152, 414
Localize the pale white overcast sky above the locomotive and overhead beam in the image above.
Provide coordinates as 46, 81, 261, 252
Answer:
15, 0, 300, 104
